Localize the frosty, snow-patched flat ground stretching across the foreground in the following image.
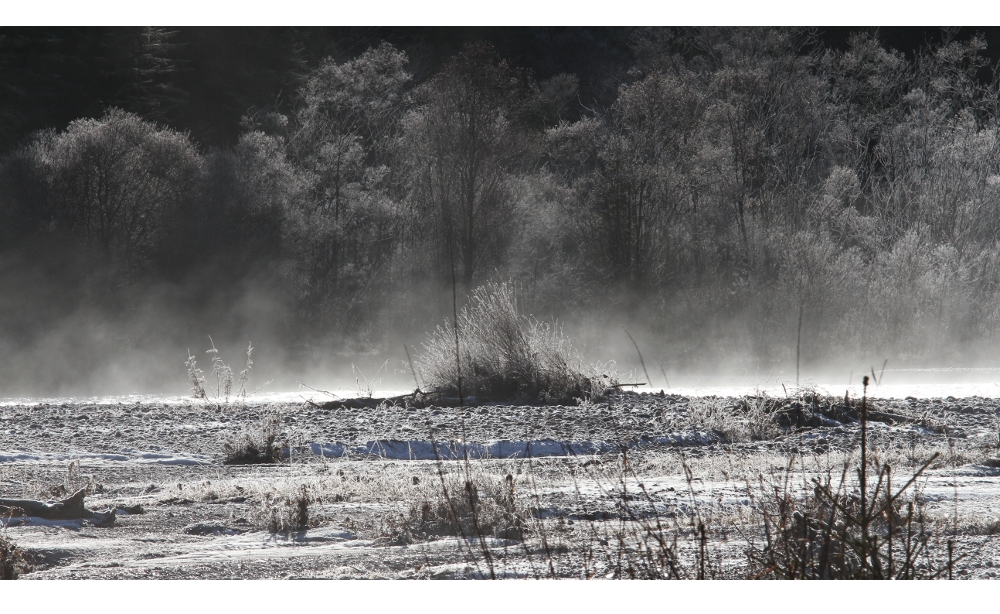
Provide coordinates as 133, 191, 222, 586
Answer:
0, 394, 1000, 579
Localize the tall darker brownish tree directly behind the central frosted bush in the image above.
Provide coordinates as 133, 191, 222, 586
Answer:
401, 44, 531, 289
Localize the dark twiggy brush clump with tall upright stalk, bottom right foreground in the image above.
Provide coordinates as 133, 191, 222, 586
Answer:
747, 376, 996, 580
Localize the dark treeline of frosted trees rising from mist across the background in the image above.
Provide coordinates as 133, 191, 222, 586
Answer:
0, 28, 1000, 396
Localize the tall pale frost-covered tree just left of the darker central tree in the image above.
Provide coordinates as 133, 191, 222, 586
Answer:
285, 43, 410, 328
